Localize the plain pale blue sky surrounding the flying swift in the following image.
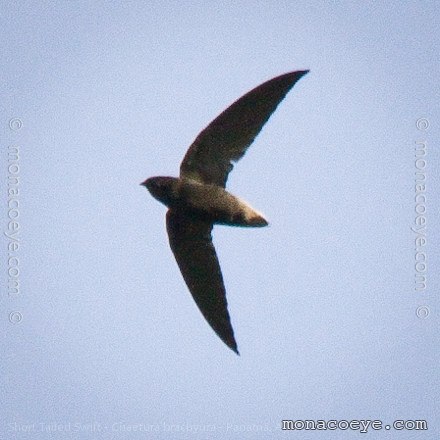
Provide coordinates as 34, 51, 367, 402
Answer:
0, 1, 440, 440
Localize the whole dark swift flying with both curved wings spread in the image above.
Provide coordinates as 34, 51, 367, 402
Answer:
142, 70, 308, 354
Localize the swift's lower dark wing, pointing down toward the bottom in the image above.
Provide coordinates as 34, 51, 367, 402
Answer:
166, 209, 238, 354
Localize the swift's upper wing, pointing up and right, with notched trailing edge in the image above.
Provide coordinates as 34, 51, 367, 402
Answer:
180, 70, 308, 187
